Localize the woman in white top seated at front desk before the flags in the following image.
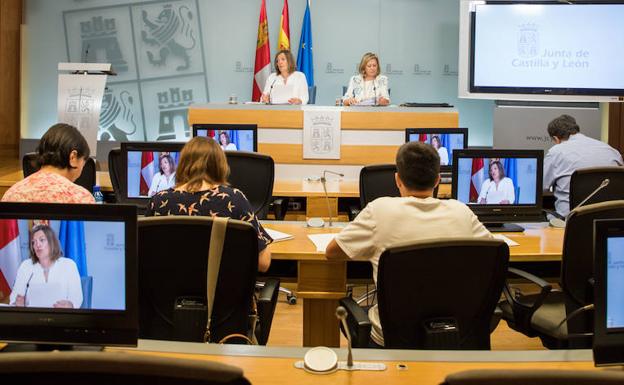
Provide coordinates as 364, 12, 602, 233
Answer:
260, 49, 309, 104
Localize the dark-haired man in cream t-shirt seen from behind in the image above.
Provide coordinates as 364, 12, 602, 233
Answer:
325, 141, 492, 346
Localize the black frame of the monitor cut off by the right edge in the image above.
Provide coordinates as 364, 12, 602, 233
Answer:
593, 219, 624, 366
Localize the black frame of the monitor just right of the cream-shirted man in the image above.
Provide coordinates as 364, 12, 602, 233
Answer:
451, 149, 544, 222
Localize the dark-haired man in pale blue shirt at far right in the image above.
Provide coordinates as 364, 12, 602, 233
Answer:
544, 115, 624, 216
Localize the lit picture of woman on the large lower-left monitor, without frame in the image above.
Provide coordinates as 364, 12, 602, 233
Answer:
0, 219, 126, 310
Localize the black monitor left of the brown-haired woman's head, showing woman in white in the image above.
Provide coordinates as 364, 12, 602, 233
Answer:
121, 142, 184, 207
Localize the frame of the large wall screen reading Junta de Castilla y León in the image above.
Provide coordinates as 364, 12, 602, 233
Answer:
468, 0, 624, 96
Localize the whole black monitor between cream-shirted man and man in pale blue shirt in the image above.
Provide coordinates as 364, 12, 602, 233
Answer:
452, 149, 544, 231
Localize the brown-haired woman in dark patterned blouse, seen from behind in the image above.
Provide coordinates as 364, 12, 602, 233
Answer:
145, 136, 272, 272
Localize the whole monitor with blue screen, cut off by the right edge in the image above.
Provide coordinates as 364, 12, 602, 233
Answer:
593, 218, 624, 366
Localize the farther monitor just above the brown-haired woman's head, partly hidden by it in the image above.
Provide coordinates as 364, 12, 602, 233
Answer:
193, 124, 258, 152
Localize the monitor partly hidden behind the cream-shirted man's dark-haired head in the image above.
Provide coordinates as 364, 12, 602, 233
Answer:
405, 128, 468, 172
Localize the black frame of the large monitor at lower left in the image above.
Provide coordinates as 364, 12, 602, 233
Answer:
0, 203, 139, 346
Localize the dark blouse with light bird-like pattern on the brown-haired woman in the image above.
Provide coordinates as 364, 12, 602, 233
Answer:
145, 185, 273, 251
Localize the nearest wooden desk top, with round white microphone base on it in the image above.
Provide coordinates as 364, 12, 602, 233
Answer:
116, 340, 600, 385
